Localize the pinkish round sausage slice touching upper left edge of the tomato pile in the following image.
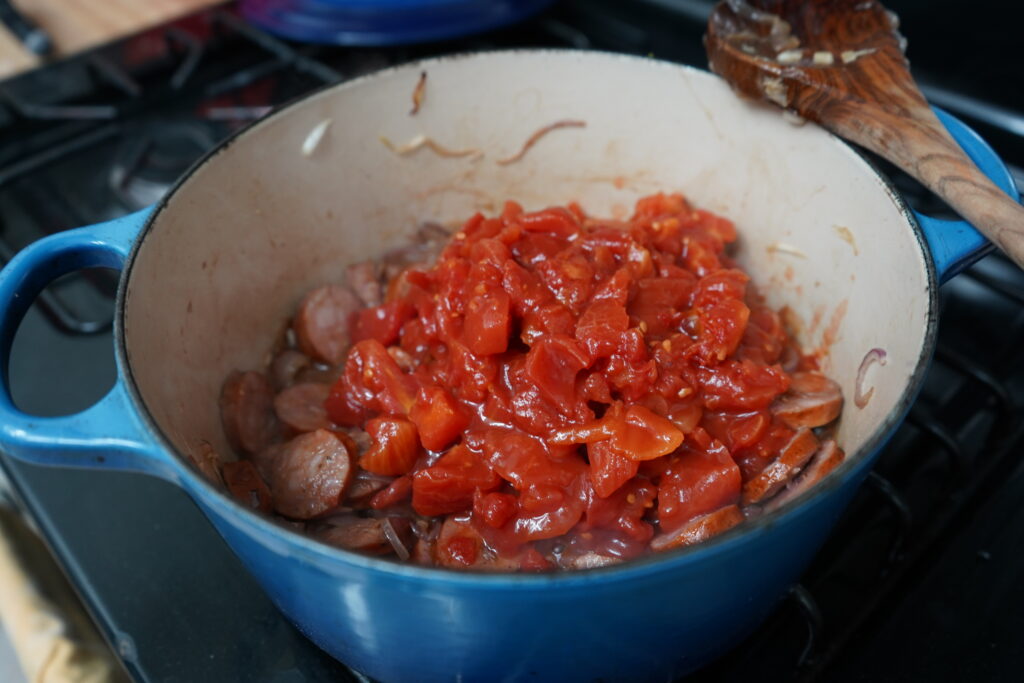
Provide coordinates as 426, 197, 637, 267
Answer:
293, 285, 361, 366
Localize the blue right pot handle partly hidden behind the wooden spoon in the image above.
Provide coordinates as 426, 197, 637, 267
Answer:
913, 106, 1020, 283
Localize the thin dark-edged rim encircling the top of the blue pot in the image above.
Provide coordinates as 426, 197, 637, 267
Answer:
114, 48, 938, 589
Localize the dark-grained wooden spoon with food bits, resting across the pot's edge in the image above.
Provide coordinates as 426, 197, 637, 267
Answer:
705, 0, 1024, 267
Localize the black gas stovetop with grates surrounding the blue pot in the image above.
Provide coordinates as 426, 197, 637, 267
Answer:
0, 0, 1024, 681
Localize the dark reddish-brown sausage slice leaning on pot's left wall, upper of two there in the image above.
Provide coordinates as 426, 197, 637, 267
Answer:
220, 371, 281, 455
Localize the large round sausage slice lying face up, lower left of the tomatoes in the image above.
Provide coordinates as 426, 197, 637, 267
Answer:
270, 429, 352, 519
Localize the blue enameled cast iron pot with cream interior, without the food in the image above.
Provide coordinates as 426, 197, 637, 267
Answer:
0, 51, 1016, 681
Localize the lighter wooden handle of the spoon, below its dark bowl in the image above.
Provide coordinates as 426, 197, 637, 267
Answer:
837, 108, 1024, 268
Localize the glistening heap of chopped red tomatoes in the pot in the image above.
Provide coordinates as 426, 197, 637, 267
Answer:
258, 194, 841, 571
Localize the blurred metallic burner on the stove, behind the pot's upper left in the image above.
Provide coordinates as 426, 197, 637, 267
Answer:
109, 120, 218, 211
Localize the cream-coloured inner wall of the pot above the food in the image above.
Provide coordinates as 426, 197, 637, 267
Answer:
124, 51, 930, 481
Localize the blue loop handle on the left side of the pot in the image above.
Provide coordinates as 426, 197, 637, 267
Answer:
0, 208, 173, 478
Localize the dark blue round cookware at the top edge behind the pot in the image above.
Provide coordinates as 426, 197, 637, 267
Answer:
240, 0, 552, 45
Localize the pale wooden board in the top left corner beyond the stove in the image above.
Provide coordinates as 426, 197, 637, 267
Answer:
0, 0, 223, 79
